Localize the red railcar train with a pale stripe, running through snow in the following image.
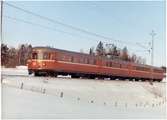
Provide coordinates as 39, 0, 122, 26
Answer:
28, 47, 165, 81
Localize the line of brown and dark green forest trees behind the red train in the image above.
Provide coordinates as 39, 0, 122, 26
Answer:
1, 41, 146, 67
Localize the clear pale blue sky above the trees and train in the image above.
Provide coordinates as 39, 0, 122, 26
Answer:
3, 1, 166, 66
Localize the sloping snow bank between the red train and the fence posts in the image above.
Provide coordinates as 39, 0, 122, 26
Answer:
3, 76, 166, 105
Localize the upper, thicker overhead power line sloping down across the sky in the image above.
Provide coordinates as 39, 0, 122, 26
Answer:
5, 2, 136, 45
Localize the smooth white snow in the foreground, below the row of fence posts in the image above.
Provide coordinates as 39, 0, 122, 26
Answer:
2, 86, 166, 119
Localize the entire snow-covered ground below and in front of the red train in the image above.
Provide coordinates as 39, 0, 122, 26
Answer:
2, 67, 166, 119
